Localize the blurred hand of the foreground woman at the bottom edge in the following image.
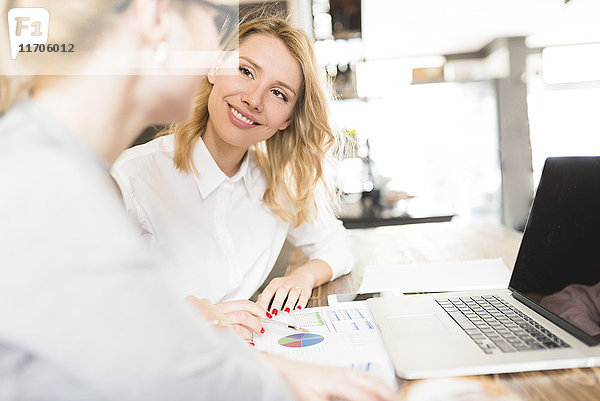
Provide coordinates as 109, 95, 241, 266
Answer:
265, 354, 395, 401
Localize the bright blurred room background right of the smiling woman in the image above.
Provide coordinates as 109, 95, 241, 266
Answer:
138, 0, 600, 230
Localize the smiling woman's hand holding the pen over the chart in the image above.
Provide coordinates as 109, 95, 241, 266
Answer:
186, 295, 271, 345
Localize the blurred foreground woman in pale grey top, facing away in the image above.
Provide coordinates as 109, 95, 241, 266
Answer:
0, 0, 392, 401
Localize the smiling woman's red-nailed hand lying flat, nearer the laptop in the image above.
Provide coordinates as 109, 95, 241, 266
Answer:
256, 271, 315, 316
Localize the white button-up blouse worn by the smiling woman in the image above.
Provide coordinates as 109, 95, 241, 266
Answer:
112, 135, 353, 302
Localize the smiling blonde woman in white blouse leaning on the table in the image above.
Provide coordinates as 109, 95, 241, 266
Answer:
112, 16, 352, 337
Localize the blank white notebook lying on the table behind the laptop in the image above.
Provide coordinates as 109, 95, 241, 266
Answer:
359, 258, 510, 293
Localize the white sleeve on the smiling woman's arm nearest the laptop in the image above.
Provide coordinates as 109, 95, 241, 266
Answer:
288, 203, 354, 280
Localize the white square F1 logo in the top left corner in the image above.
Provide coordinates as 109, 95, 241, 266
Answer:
8, 8, 50, 60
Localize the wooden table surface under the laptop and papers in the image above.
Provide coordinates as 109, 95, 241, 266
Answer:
288, 222, 600, 401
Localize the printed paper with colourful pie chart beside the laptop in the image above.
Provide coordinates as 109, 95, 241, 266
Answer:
254, 302, 396, 388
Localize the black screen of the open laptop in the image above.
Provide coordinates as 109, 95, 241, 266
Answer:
509, 157, 600, 340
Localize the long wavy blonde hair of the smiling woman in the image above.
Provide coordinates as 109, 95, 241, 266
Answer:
166, 15, 341, 226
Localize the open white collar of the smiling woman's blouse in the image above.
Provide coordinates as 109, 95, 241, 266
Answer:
194, 137, 252, 199
